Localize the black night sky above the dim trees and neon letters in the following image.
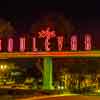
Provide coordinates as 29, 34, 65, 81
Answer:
0, 0, 100, 48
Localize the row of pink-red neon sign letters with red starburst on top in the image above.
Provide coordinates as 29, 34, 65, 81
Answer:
0, 28, 92, 52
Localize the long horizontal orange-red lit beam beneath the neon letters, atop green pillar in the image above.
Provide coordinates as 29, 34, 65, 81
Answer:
0, 51, 100, 59
